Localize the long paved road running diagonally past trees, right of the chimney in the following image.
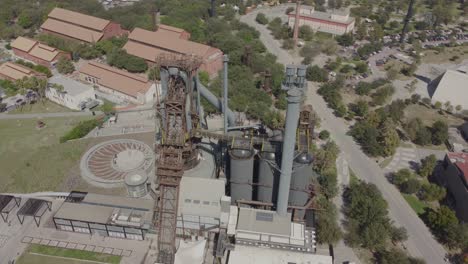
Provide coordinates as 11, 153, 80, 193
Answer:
241, 5, 446, 264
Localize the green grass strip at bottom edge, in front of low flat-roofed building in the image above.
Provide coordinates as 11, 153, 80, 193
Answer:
18, 245, 122, 264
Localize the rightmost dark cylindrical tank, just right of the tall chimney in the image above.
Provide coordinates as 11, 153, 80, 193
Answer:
289, 153, 313, 218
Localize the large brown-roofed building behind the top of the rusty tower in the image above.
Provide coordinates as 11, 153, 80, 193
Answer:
123, 25, 223, 76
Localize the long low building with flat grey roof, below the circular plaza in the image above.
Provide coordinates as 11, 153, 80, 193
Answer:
53, 192, 154, 240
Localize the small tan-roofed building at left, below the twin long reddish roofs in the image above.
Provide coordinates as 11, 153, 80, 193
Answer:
11, 37, 71, 68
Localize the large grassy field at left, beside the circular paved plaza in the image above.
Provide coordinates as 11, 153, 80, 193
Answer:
0, 117, 90, 192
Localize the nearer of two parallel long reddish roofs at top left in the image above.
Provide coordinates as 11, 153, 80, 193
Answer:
41, 18, 103, 43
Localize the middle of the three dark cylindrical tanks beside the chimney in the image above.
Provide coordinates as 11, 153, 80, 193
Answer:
257, 152, 279, 203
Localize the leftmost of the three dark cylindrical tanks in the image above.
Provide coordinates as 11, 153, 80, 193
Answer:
229, 149, 254, 204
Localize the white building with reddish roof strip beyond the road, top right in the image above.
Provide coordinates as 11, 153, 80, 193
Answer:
288, 6, 355, 35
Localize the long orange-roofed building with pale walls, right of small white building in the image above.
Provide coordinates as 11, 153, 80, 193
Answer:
79, 61, 161, 104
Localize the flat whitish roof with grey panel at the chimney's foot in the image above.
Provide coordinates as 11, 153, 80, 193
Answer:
237, 207, 291, 236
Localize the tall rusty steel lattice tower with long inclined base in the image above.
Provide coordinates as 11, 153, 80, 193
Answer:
154, 55, 201, 264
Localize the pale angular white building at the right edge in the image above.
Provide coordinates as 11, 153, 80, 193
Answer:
429, 66, 468, 110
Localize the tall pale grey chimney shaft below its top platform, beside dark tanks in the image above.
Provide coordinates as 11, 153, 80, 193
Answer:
276, 88, 302, 216
